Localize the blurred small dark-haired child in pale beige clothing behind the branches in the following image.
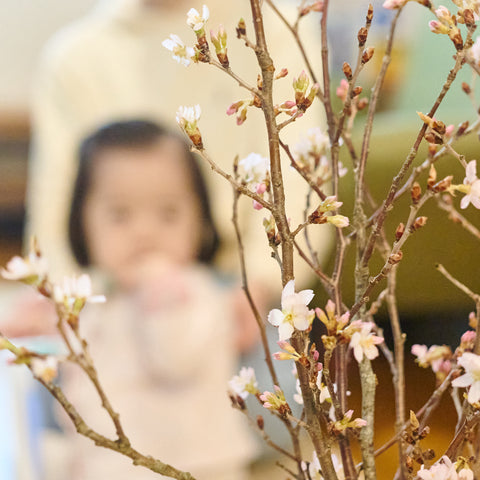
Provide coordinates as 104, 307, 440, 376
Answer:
54, 121, 256, 480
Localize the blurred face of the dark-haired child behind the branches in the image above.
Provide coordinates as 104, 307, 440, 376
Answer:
83, 139, 201, 287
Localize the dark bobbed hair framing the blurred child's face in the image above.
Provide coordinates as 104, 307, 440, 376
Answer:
68, 120, 219, 267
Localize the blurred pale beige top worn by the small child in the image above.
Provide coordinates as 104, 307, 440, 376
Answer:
64, 267, 254, 480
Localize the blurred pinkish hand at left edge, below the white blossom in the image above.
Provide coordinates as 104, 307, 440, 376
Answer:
0, 291, 57, 338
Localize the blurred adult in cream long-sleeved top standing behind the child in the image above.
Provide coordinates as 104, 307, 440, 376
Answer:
26, 0, 332, 287
